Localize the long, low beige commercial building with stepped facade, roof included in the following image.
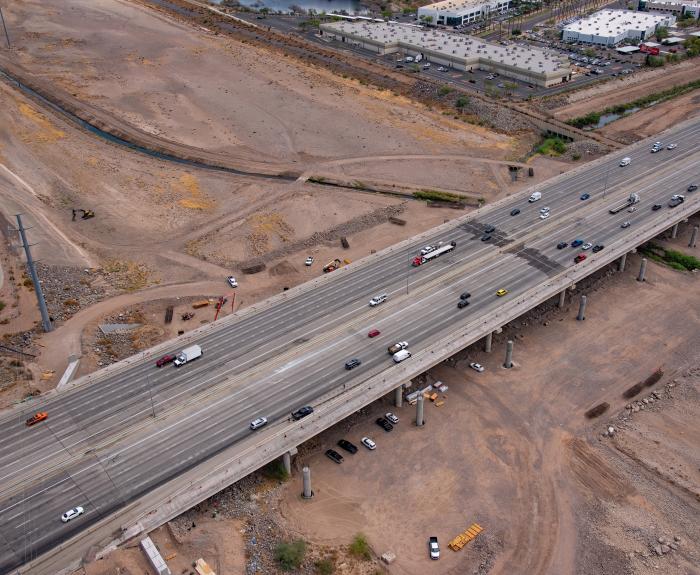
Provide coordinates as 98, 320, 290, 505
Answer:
321, 21, 571, 87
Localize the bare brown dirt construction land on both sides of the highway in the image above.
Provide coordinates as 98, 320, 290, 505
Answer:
0, 0, 700, 575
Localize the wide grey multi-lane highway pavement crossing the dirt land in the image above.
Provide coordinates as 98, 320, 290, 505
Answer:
0, 121, 700, 573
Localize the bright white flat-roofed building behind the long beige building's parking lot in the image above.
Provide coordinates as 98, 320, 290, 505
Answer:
562, 10, 676, 46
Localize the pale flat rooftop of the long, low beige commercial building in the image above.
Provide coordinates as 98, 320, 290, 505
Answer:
323, 22, 569, 73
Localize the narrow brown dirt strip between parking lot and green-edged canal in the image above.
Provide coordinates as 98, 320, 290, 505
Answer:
552, 60, 700, 120
